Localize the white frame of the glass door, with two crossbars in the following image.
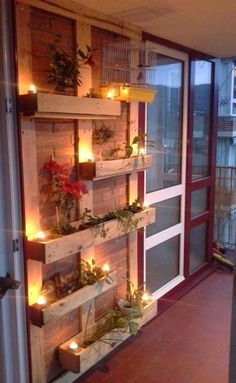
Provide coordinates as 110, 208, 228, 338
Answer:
144, 43, 189, 299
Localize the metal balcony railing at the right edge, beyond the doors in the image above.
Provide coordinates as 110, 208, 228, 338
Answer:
214, 166, 236, 248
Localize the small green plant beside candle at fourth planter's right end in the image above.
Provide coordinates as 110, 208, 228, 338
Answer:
80, 259, 112, 286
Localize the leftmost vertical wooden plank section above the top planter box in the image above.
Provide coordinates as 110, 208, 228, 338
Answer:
15, 2, 32, 94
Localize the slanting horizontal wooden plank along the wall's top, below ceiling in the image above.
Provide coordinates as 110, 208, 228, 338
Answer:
18, 0, 142, 41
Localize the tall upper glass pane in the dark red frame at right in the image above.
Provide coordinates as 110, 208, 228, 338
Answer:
191, 61, 212, 180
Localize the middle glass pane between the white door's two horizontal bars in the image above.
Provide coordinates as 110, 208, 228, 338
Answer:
146, 197, 180, 237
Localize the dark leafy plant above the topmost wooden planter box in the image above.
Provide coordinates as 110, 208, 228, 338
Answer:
48, 44, 95, 92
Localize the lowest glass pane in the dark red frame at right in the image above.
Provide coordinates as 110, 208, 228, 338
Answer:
189, 223, 207, 273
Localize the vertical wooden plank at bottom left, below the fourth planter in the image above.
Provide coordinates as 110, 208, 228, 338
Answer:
30, 324, 47, 383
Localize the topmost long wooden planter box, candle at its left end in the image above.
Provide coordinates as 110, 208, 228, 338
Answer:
20, 93, 121, 119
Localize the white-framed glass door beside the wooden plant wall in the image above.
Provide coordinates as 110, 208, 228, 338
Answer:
144, 46, 188, 298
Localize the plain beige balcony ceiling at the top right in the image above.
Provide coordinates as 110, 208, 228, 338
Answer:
76, 0, 236, 57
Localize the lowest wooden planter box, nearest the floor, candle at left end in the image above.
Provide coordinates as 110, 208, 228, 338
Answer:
59, 301, 157, 373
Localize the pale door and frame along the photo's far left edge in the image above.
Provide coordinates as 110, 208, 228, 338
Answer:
0, 0, 28, 383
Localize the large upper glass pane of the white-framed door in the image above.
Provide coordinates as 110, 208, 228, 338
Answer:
147, 55, 182, 193
